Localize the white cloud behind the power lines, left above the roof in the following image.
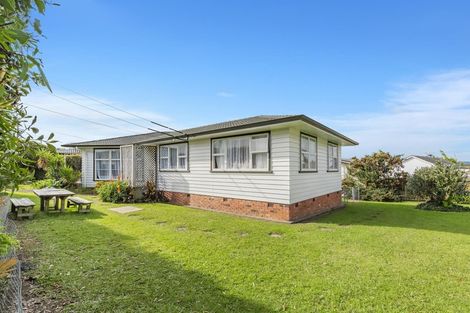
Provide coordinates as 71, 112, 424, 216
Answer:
23, 90, 169, 145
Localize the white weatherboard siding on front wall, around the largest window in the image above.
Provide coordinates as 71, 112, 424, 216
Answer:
157, 128, 290, 204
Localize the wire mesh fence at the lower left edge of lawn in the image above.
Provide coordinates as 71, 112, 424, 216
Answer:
0, 198, 23, 313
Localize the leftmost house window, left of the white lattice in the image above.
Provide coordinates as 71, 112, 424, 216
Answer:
95, 149, 121, 180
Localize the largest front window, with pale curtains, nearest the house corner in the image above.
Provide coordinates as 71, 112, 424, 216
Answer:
212, 133, 269, 171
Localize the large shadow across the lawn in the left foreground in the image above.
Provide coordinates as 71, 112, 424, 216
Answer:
23, 214, 272, 312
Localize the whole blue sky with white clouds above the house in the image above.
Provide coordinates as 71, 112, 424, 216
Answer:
24, 0, 470, 160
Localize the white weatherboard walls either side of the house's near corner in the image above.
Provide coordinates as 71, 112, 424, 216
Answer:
157, 128, 341, 204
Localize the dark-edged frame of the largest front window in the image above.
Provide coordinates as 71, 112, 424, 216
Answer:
210, 131, 272, 173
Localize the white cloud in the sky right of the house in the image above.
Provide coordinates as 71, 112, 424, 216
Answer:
331, 70, 470, 160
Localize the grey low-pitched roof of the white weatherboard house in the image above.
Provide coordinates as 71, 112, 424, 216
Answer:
63, 115, 358, 147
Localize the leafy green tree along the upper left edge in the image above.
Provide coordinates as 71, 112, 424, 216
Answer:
0, 0, 54, 192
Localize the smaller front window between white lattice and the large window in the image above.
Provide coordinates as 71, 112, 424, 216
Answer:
160, 143, 188, 171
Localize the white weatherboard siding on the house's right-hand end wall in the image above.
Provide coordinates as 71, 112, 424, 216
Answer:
290, 129, 341, 203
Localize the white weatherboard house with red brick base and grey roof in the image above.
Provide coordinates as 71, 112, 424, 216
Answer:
65, 115, 357, 222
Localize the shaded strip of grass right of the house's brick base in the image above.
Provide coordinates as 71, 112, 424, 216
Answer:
307, 201, 470, 235
